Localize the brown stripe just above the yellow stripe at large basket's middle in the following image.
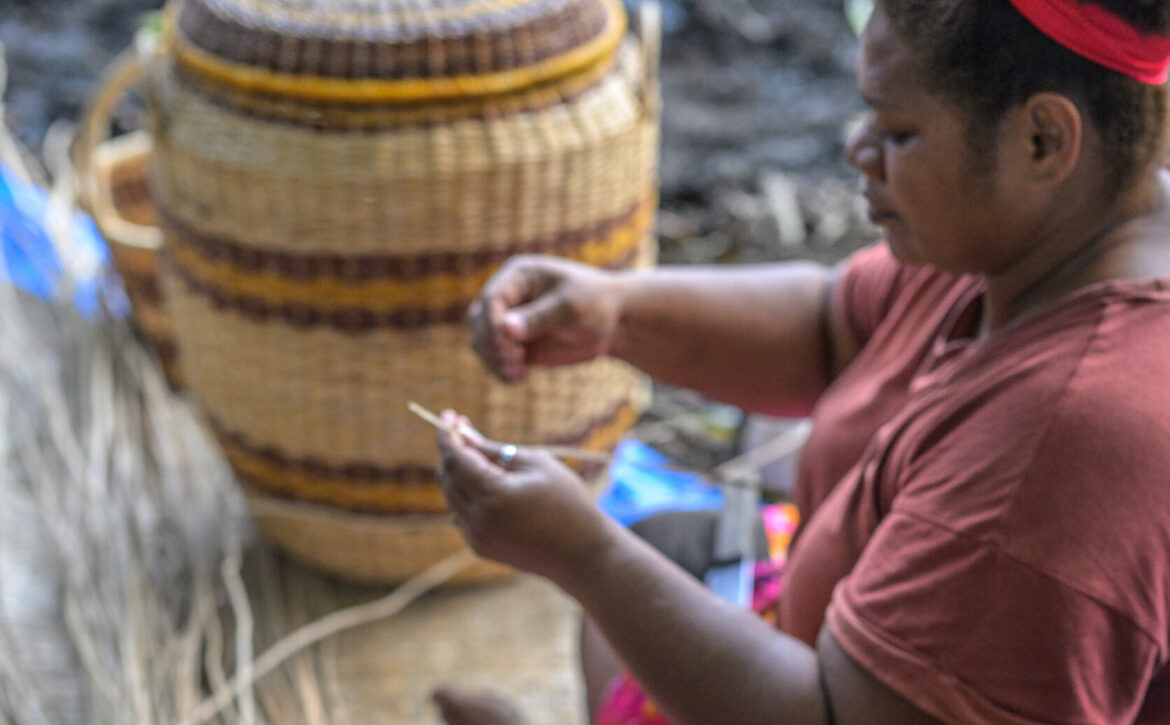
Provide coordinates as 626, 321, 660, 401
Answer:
157, 194, 656, 283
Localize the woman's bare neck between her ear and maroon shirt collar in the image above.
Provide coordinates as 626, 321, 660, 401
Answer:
982, 167, 1170, 334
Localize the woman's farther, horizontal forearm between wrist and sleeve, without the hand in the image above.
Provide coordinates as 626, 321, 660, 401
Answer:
610, 263, 833, 416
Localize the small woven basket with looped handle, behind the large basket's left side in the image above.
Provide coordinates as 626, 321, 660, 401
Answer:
74, 49, 183, 389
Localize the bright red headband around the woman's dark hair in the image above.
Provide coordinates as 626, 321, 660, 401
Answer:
1011, 0, 1170, 84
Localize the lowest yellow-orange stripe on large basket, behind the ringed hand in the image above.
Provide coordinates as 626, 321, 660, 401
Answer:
219, 403, 638, 515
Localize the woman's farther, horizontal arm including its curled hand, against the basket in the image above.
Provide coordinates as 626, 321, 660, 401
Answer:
472, 256, 856, 415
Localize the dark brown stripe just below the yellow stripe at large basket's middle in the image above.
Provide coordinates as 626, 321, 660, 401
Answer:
159, 247, 640, 334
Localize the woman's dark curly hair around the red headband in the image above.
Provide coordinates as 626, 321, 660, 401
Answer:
881, 0, 1170, 196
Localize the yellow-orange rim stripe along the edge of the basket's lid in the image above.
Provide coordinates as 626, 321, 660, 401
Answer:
166, 0, 626, 103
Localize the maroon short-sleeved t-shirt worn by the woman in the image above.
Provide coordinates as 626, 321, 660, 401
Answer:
778, 246, 1170, 724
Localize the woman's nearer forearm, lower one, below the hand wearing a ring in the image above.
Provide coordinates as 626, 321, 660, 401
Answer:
558, 522, 827, 725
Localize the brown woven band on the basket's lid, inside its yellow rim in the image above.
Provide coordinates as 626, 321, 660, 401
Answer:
179, 0, 610, 80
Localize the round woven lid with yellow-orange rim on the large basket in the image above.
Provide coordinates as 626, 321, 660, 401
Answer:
168, 0, 626, 103
